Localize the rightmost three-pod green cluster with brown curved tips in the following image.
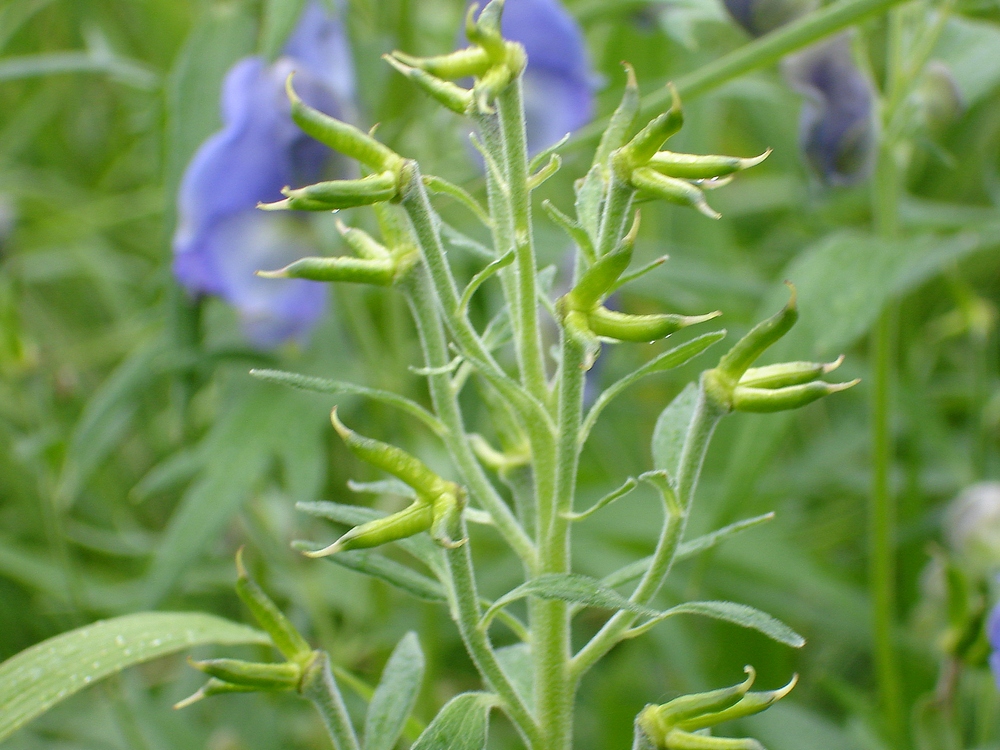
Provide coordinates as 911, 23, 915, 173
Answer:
702, 285, 860, 412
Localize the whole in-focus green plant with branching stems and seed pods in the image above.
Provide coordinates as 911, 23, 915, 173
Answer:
178, 0, 853, 750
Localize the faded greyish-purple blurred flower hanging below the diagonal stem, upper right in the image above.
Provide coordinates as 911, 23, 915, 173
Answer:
784, 33, 877, 185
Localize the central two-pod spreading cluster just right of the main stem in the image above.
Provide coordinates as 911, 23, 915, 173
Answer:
556, 211, 721, 369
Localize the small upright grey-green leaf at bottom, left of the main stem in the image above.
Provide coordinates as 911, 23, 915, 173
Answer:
364, 632, 424, 750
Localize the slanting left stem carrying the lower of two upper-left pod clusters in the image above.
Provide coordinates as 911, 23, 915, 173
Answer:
404, 267, 536, 570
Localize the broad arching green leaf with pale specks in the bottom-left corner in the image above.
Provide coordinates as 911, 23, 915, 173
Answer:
0, 612, 271, 741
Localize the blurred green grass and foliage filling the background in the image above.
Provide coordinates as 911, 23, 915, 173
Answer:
0, 0, 1000, 750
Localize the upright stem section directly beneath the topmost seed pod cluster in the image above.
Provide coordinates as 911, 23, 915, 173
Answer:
496, 77, 548, 403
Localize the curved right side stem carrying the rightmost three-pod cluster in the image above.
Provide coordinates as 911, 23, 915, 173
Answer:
570, 385, 725, 680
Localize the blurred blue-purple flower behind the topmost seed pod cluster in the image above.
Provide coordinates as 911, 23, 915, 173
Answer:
463, 0, 599, 154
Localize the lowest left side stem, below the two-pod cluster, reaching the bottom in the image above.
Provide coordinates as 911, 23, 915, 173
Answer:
446, 520, 541, 748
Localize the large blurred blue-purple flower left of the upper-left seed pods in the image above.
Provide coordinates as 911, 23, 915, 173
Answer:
173, 0, 354, 348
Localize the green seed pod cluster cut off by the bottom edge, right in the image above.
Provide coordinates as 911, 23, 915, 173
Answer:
633, 666, 798, 750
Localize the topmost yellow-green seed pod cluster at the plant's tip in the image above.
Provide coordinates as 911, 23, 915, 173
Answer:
385, 2, 528, 115
